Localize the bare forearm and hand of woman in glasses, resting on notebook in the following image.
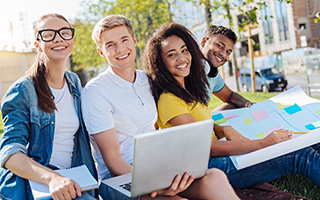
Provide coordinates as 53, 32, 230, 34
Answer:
4, 153, 81, 199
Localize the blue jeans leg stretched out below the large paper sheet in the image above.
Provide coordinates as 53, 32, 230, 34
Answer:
209, 147, 320, 188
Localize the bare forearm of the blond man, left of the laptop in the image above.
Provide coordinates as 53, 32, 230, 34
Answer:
92, 128, 132, 176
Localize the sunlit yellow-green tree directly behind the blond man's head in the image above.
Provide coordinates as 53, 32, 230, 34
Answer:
73, 0, 172, 71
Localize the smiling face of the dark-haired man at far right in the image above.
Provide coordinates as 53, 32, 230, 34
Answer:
200, 34, 234, 67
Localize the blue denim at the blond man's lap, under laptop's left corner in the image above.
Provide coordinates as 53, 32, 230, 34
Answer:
99, 172, 138, 200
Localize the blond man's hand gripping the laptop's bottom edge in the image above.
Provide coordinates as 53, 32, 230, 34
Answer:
141, 172, 194, 199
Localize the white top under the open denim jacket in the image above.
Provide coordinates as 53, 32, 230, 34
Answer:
49, 82, 80, 169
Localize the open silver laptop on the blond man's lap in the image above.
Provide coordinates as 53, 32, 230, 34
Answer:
102, 119, 213, 197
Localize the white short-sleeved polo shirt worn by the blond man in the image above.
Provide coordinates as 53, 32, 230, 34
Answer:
81, 67, 157, 178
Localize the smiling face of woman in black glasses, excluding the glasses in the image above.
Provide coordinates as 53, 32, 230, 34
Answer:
35, 16, 74, 62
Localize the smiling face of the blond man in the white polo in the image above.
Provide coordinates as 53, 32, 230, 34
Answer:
98, 26, 137, 71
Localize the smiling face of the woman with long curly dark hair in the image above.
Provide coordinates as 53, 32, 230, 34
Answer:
161, 35, 192, 86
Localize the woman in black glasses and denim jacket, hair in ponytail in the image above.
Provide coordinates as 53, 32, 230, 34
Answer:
0, 14, 97, 200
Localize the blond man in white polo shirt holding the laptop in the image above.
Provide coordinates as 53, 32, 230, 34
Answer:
81, 15, 238, 200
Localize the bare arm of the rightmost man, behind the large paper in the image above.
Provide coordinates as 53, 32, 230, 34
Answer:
213, 84, 253, 109
